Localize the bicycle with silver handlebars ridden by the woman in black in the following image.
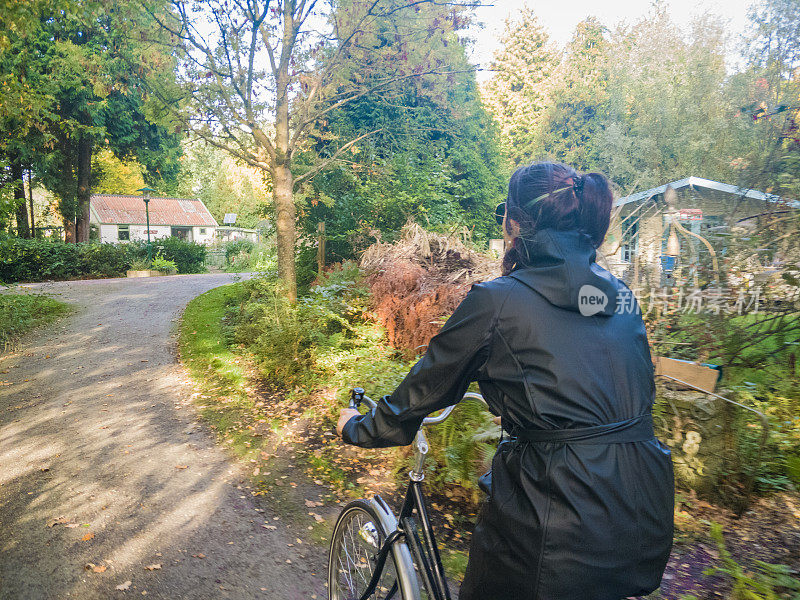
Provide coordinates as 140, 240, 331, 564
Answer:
328, 388, 484, 600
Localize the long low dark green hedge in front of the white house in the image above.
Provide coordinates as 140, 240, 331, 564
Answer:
0, 237, 206, 283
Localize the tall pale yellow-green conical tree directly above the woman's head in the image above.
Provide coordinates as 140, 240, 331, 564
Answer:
483, 6, 559, 165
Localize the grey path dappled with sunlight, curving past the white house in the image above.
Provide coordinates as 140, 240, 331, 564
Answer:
0, 274, 326, 600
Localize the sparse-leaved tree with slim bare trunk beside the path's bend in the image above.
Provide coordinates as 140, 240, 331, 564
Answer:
152, 0, 482, 299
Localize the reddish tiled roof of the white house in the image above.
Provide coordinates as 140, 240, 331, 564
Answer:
90, 194, 217, 227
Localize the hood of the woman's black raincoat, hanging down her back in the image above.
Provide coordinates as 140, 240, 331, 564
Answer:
510, 229, 617, 317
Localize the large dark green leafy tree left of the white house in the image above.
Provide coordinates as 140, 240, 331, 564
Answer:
0, 0, 179, 241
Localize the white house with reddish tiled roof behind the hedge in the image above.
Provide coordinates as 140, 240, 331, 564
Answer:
89, 194, 217, 244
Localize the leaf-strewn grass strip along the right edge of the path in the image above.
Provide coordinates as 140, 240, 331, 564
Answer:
178, 283, 336, 544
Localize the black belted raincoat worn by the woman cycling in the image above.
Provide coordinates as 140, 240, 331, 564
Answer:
343, 229, 674, 600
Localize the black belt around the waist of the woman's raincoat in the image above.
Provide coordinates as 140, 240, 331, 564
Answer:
511, 413, 655, 444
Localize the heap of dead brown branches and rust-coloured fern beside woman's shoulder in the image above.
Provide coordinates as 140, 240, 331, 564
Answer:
361, 223, 499, 357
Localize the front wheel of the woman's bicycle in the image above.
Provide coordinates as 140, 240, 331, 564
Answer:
328, 500, 420, 600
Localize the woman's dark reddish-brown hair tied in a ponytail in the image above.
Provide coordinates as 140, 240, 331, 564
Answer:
503, 162, 614, 274
